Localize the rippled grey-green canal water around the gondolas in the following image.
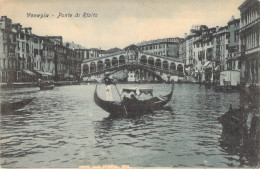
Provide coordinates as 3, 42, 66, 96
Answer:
0, 84, 257, 168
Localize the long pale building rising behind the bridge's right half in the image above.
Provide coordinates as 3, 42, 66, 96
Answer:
137, 37, 183, 58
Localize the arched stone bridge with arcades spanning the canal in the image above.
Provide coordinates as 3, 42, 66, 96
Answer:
81, 45, 185, 81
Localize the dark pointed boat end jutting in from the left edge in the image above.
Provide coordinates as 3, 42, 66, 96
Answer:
1, 98, 34, 113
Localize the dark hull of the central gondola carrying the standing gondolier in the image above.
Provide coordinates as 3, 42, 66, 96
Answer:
94, 85, 173, 116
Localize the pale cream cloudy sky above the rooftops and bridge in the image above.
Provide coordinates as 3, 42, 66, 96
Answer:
0, 0, 245, 50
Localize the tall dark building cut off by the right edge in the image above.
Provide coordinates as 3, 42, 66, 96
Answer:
238, 0, 260, 85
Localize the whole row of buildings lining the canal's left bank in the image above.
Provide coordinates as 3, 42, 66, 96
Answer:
0, 16, 84, 83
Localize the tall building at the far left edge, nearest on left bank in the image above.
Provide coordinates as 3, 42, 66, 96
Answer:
0, 16, 17, 83
